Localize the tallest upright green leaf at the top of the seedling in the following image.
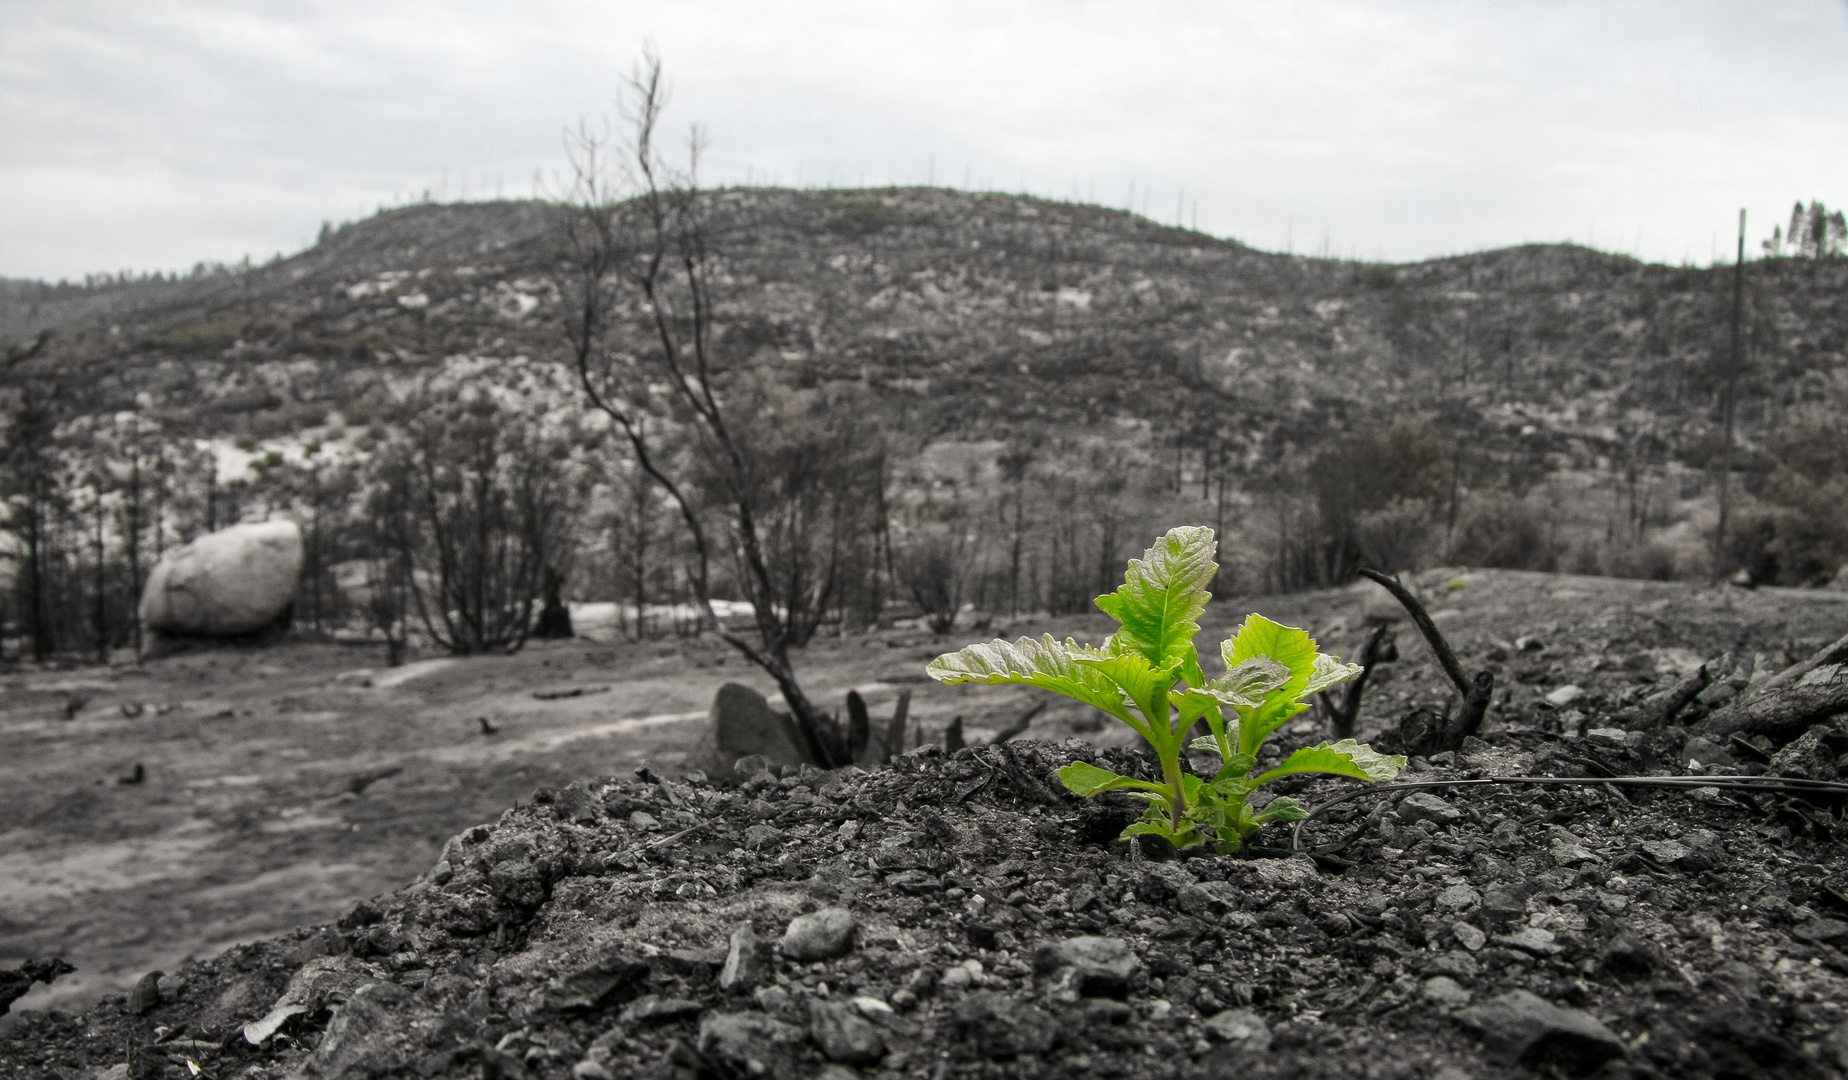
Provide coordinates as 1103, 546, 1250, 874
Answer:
1096, 525, 1220, 675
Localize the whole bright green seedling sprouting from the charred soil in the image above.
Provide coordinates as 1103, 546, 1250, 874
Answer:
926, 525, 1404, 854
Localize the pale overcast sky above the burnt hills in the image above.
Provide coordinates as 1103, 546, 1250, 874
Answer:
0, 0, 1848, 277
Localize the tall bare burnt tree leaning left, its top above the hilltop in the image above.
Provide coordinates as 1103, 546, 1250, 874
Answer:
560, 52, 850, 767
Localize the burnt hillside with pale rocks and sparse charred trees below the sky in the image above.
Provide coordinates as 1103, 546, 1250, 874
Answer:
0, 189, 1848, 636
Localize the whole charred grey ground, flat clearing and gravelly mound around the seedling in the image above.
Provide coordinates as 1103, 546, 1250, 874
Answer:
0, 571, 1848, 1080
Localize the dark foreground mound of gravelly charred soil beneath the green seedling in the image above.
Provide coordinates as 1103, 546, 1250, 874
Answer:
0, 732, 1848, 1078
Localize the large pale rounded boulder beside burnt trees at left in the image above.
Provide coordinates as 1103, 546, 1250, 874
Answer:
140, 522, 301, 638
